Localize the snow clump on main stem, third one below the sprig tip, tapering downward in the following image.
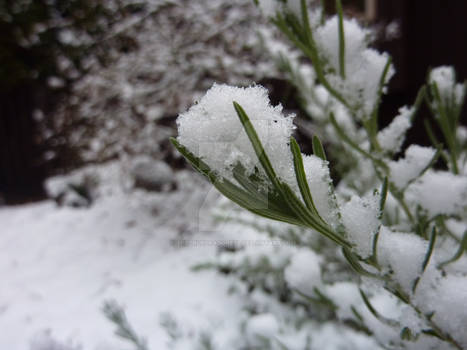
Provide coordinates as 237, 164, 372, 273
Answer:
377, 226, 428, 295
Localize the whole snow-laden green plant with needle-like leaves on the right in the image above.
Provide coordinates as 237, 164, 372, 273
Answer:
172, 0, 467, 349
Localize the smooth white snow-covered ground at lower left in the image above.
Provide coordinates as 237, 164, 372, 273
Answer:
0, 165, 240, 350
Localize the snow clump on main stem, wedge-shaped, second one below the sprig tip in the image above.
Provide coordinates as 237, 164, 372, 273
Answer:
341, 191, 380, 258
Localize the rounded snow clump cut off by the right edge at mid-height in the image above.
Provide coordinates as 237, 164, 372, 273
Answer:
406, 170, 467, 216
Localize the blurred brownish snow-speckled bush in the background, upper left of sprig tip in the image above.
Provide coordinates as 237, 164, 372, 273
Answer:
48, 0, 276, 162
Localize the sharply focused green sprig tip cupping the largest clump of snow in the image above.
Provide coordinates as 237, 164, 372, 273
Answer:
172, 85, 350, 248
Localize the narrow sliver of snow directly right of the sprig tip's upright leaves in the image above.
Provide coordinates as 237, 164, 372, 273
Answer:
303, 155, 337, 224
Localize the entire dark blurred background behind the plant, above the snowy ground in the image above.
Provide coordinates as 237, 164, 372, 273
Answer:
0, 0, 467, 203
